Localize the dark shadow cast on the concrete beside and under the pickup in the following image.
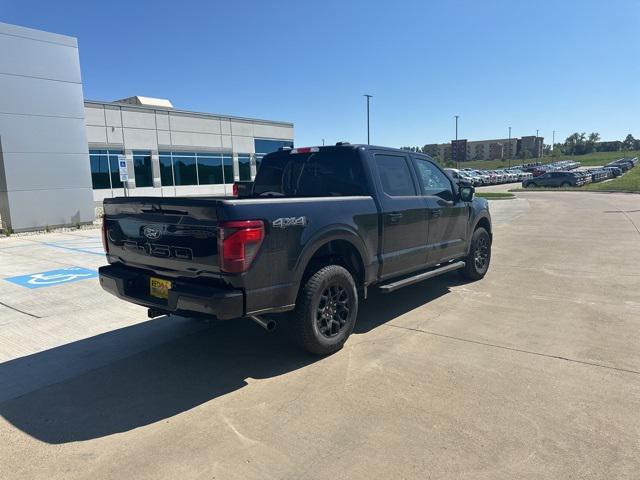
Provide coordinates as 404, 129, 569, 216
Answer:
0, 275, 457, 444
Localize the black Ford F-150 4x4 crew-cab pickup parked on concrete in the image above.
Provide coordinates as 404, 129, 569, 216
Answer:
100, 143, 492, 354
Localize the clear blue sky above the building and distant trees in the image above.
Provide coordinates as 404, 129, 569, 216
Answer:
0, 0, 640, 146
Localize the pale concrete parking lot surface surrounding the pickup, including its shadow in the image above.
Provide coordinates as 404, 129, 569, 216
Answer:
0, 191, 640, 479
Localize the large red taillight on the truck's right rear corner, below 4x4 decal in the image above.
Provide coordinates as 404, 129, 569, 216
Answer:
218, 220, 264, 273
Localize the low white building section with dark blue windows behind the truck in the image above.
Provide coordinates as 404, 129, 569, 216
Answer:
85, 97, 293, 200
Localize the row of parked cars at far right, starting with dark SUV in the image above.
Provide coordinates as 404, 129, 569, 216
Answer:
522, 157, 638, 188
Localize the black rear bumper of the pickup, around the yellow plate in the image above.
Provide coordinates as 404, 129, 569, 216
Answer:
99, 265, 244, 320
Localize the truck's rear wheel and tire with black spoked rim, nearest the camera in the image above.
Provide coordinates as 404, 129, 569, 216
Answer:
289, 265, 358, 355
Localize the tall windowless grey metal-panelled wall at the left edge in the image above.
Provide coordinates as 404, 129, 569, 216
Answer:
0, 23, 94, 231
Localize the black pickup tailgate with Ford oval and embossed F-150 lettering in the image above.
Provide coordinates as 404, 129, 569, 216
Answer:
104, 197, 222, 277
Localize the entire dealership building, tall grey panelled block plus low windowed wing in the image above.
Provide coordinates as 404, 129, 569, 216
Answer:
0, 23, 293, 231
